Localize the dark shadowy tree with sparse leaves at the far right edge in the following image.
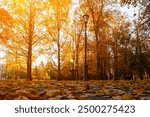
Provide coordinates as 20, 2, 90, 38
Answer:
121, 0, 150, 80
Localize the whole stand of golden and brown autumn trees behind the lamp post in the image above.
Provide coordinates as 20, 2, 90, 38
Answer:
0, 0, 150, 80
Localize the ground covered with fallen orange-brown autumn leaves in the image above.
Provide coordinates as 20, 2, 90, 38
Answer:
0, 80, 150, 100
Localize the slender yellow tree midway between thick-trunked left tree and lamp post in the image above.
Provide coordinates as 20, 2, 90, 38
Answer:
44, 0, 72, 80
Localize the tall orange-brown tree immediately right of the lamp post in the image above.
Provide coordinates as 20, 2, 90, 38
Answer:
79, 0, 118, 79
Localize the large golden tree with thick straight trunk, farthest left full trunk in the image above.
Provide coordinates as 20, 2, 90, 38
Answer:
2, 0, 45, 80
